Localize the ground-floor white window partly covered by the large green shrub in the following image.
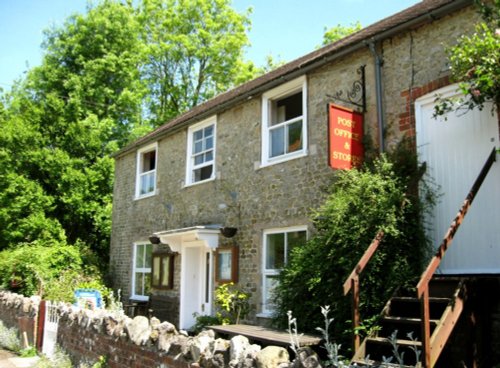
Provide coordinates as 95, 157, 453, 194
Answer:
262, 226, 307, 315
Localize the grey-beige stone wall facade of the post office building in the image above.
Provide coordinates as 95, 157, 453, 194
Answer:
111, 7, 478, 323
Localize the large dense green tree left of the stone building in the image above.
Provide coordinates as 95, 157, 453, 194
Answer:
0, 1, 145, 260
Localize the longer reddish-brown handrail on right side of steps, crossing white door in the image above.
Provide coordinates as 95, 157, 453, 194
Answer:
417, 147, 496, 367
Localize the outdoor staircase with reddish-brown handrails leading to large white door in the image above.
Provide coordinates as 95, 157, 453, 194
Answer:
344, 147, 496, 368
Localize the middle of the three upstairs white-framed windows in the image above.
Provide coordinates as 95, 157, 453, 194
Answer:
186, 118, 215, 185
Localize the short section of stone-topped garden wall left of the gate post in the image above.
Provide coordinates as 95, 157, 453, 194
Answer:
0, 291, 40, 345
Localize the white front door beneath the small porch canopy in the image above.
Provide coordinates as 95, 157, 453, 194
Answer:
179, 242, 212, 330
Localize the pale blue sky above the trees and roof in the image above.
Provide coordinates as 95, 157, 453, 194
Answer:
0, 0, 419, 90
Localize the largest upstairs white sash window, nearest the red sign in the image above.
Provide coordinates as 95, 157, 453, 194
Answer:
262, 77, 307, 165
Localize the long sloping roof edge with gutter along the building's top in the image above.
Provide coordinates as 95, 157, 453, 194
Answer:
113, 0, 472, 158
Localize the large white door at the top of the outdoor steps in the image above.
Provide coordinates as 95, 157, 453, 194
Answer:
415, 86, 500, 274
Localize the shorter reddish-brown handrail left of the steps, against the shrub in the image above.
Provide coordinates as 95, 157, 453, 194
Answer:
344, 230, 384, 351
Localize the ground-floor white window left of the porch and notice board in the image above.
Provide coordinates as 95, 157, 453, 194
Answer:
132, 243, 153, 300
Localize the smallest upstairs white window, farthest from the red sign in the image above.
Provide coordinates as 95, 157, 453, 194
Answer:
135, 143, 158, 198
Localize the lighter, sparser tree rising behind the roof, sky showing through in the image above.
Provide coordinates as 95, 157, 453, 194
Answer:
138, 0, 254, 126
